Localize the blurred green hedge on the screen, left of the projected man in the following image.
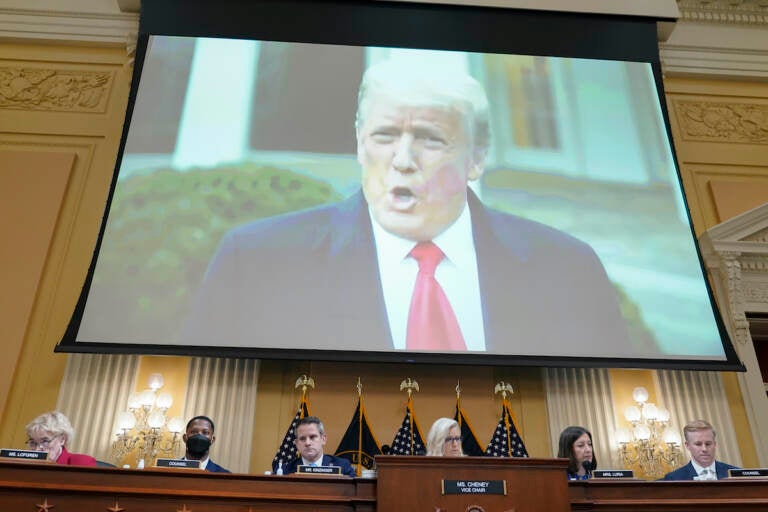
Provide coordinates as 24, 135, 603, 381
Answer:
88, 164, 341, 344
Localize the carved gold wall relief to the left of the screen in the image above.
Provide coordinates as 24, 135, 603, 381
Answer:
0, 67, 114, 112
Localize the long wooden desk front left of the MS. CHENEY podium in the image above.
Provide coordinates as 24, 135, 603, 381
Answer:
0, 462, 376, 512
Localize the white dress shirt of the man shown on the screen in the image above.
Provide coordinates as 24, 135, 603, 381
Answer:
369, 204, 485, 351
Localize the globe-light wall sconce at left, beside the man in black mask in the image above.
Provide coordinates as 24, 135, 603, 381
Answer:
112, 373, 184, 467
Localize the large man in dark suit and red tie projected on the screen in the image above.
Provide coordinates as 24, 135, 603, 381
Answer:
184, 57, 636, 357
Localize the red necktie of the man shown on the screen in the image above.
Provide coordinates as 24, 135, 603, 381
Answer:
405, 242, 467, 350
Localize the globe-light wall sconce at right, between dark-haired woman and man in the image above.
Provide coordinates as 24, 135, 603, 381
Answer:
616, 386, 681, 479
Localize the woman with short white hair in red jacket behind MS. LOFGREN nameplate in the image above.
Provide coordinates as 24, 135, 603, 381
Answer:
26, 411, 96, 466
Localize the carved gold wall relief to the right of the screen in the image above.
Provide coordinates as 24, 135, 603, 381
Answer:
674, 100, 768, 144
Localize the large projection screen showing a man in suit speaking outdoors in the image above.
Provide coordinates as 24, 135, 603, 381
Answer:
57, 0, 738, 369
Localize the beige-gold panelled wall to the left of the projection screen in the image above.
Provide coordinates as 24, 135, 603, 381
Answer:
0, 43, 131, 446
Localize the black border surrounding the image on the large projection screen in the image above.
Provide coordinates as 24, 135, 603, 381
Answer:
54, 0, 746, 371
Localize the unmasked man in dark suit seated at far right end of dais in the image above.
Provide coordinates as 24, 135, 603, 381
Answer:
662, 420, 736, 480
